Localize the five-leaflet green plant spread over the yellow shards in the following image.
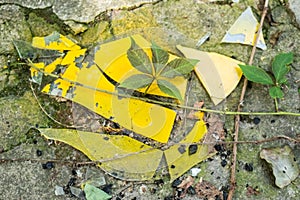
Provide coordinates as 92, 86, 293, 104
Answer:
119, 38, 198, 100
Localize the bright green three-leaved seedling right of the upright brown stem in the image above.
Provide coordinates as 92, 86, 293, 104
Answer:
239, 53, 294, 110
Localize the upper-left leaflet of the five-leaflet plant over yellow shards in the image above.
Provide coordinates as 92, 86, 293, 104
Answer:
127, 38, 152, 74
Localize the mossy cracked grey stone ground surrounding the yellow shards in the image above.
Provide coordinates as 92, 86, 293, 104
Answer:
0, 0, 300, 200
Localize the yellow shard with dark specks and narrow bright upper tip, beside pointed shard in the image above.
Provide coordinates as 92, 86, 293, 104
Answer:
164, 120, 211, 181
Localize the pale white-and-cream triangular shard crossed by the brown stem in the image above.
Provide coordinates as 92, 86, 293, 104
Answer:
221, 7, 267, 50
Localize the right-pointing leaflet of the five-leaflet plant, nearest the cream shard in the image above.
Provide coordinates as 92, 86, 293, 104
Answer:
160, 58, 199, 78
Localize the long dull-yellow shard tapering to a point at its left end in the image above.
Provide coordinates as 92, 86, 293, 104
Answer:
39, 129, 163, 180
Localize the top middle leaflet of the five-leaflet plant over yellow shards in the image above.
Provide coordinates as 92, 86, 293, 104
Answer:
151, 42, 169, 73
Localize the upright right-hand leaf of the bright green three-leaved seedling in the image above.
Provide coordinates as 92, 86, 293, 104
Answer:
272, 53, 294, 83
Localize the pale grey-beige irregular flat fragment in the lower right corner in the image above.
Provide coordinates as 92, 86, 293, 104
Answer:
260, 145, 299, 188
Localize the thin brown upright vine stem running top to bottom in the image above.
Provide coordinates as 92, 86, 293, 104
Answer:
227, 0, 269, 200
